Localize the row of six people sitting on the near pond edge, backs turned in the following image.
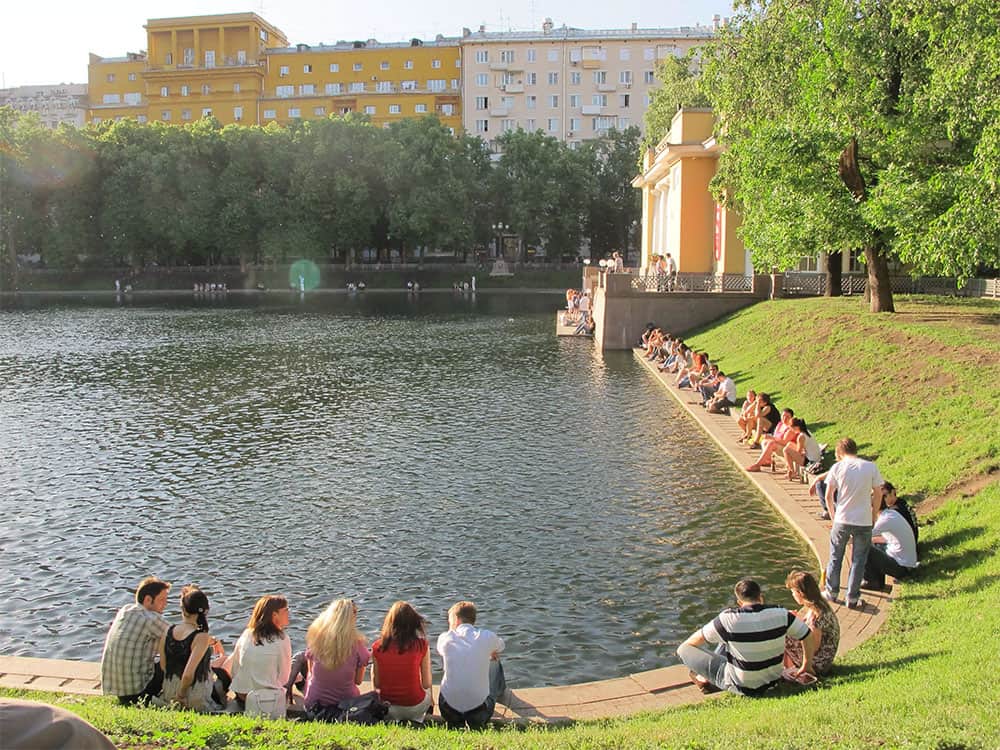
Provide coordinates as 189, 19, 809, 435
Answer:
101, 577, 506, 728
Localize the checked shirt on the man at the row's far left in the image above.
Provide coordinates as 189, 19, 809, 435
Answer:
101, 604, 167, 695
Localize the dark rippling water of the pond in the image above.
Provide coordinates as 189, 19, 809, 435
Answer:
0, 292, 814, 687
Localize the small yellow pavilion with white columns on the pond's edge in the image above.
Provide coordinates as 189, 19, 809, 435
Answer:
632, 108, 753, 276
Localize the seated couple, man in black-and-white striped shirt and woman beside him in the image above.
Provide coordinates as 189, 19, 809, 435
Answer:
677, 571, 840, 696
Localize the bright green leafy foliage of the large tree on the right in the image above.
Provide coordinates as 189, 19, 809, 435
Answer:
704, 0, 1000, 308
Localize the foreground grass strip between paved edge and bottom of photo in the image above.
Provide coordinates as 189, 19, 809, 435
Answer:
3, 483, 1000, 750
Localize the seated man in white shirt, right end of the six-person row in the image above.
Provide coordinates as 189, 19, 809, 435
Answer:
438, 602, 507, 729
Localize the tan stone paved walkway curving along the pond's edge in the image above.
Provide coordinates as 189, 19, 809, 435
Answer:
0, 352, 892, 723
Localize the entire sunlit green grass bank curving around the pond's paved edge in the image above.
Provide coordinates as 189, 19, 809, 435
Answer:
3, 300, 1000, 750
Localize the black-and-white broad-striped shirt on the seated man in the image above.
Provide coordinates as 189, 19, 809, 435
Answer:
701, 604, 809, 695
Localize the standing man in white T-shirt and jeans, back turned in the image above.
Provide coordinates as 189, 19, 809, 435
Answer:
823, 438, 885, 609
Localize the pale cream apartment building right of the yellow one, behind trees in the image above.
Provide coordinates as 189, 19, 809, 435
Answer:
462, 19, 714, 148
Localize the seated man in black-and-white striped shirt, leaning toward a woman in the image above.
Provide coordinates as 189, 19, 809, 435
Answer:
677, 578, 815, 695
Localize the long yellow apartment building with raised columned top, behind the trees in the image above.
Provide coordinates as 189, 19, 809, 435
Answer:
87, 13, 462, 130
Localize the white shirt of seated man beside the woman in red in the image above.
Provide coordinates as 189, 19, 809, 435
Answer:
438, 623, 504, 712
